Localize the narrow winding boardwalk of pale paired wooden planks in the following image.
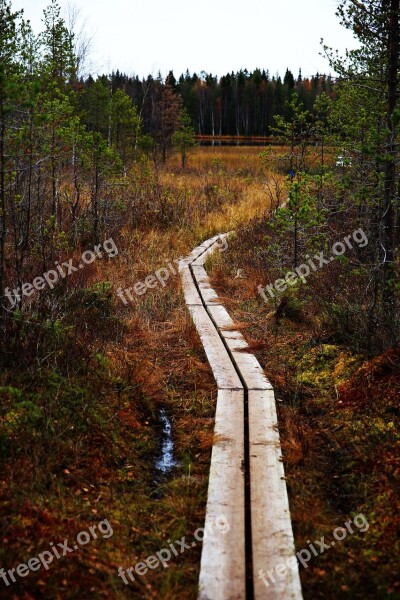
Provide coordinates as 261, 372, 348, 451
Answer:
180, 234, 302, 600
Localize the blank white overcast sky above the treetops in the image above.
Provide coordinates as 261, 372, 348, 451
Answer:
12, 0, 355, 76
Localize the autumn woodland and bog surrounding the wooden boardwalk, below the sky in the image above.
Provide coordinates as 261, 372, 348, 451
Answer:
0, 0, 400, 600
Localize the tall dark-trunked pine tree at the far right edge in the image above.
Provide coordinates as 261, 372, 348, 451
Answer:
324, 0, 400, 332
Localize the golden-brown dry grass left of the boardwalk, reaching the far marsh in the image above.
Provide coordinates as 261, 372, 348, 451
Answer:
0, 148, 294, 600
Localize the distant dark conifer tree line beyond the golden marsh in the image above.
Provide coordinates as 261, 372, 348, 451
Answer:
80, 69, 334, 136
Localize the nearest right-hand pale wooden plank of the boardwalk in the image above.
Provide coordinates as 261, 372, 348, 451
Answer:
249, 390, 302, 600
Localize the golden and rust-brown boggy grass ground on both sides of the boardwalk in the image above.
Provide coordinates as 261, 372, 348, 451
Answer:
0, 147, 399, 600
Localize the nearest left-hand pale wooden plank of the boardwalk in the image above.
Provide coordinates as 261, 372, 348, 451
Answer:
199, 390, 246, 600
